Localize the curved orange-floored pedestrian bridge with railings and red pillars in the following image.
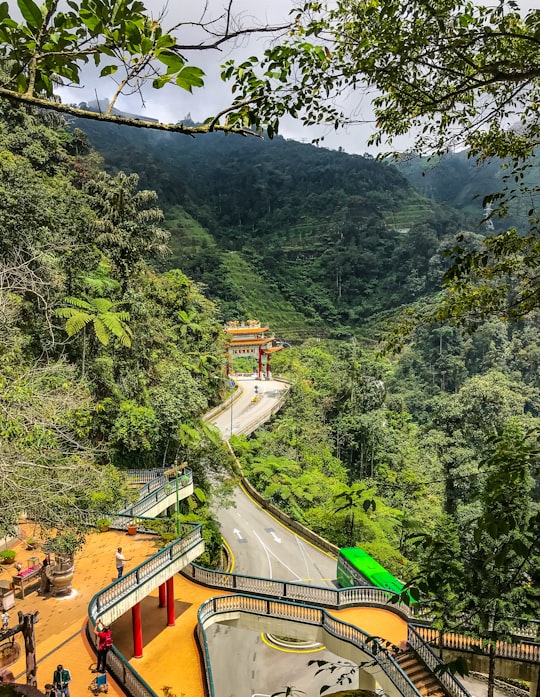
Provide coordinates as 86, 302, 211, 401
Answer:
88, 525, 540, 697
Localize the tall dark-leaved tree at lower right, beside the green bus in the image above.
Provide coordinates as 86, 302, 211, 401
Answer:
420, 420, 540, 697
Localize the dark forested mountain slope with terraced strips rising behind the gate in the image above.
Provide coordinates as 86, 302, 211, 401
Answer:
73, 115, 468, 338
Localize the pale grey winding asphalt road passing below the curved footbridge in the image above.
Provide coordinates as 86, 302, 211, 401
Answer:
208, 378, 350, 697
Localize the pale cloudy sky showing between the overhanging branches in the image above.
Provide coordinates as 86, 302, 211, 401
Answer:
54, 0, 384, 153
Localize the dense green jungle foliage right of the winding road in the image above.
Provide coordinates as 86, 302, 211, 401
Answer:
233, 326, 540, 624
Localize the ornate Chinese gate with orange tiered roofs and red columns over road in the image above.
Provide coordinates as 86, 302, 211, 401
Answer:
225, 319, 283, 380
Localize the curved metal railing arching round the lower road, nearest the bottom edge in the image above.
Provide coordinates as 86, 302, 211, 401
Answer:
197, 595, 421, 697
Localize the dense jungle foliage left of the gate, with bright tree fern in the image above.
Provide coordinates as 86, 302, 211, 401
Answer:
0, 102, 228, 548
